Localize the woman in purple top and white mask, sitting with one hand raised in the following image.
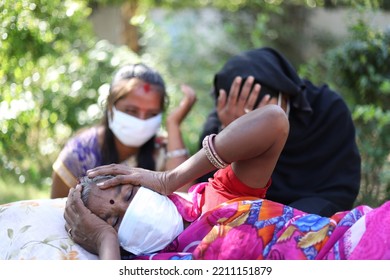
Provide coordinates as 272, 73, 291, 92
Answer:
51, 64, 196, 198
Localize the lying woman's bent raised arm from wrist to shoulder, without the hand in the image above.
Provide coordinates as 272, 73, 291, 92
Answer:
167, 105, 288, 191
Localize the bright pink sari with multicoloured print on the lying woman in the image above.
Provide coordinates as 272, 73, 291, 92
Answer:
137, 184, 390, 260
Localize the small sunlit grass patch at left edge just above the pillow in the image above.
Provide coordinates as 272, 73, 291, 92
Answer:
0, 178, 50, 204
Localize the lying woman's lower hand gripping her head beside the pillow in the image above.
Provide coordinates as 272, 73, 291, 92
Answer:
64, 185, 117, 254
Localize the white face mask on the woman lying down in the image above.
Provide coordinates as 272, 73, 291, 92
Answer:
118, 187, 184, 255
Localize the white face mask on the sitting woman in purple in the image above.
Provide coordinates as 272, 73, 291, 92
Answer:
108, 106, 162, 147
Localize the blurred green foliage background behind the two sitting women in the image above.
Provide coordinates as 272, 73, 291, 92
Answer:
0, 0, 390, 205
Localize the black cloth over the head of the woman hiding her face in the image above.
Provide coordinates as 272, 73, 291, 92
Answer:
214, 47, 312, 118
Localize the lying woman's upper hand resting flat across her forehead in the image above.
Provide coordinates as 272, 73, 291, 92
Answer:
87, 164, 175, 195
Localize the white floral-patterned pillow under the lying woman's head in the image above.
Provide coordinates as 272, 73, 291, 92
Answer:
0, 198, 98, 260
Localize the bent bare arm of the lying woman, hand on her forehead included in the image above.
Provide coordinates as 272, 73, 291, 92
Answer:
88, 105, 288, 194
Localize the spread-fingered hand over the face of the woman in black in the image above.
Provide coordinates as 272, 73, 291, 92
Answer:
217, 76, 271, 127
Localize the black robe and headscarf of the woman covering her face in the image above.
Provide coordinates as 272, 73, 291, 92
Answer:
199, 48, 361, 216
